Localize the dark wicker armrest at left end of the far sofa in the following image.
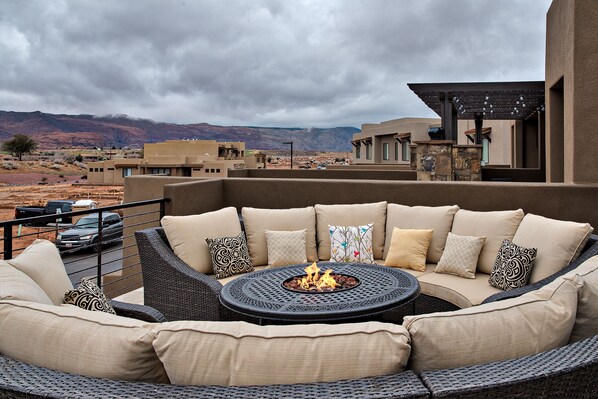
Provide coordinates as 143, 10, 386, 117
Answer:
135, 228, 227, 321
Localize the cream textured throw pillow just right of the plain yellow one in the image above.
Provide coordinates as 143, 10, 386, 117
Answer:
434, 233, 486, 278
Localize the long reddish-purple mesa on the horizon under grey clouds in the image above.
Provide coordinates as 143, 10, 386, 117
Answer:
0, 111, 360, 152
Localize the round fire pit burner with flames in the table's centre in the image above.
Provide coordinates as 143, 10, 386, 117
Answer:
282, 262, 360, 294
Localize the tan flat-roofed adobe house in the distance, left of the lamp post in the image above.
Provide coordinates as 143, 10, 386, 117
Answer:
87, 140, 266, 184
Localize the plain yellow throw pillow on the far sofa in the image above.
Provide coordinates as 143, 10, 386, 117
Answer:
384, 227, 434, 272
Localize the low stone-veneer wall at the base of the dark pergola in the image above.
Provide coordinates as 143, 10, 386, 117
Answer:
414, 140, 482, 181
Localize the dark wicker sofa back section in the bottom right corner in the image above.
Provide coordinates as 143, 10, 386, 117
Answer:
420, 335, 598, 398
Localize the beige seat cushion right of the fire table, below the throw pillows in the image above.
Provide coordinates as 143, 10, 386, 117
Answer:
417, 267, 502, 308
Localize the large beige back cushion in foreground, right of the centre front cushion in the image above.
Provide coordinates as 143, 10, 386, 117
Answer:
403, 279, 577, 372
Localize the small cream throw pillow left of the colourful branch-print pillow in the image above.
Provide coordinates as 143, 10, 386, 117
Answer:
265, 229, 307, 269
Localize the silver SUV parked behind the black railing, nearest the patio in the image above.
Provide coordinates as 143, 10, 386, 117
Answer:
56, 212, 123, 251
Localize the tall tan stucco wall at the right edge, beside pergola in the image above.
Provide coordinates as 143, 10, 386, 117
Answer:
546, 0, 598, 183
